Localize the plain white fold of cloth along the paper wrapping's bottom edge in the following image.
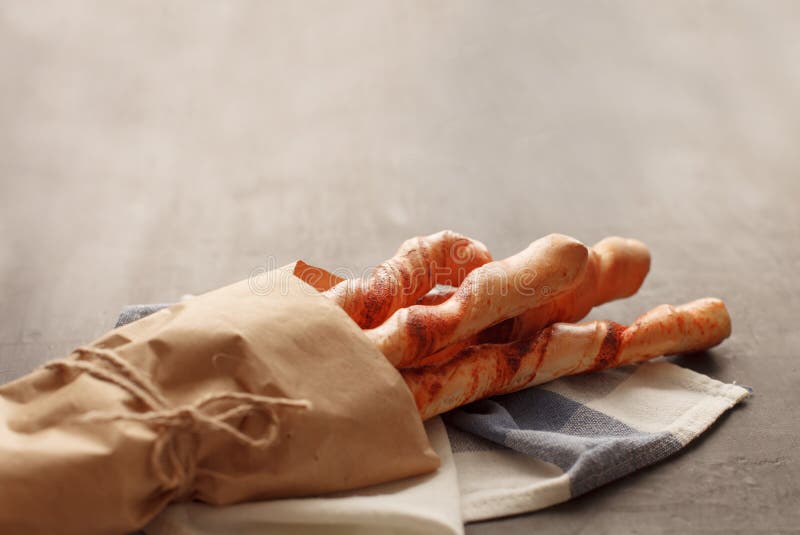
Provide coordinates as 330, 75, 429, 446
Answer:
145, 418, 464, 535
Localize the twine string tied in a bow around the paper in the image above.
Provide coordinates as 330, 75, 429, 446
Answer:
44, 346, 311, 496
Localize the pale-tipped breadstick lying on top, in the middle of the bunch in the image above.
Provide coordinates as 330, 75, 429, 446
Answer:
364, 234, 588, 367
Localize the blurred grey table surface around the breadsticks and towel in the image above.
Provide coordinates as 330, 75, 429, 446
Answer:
0, 0, 800, 535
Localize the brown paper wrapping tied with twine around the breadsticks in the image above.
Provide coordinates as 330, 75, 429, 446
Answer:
0, 263, 439, 534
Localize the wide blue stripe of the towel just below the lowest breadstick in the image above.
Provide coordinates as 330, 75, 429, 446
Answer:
444, 376, 682, 496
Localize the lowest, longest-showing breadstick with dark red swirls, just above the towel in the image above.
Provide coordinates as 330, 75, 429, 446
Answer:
401, 298, 731, 419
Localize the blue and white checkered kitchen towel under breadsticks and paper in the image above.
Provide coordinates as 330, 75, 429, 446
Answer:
117, 305, 749, 534
